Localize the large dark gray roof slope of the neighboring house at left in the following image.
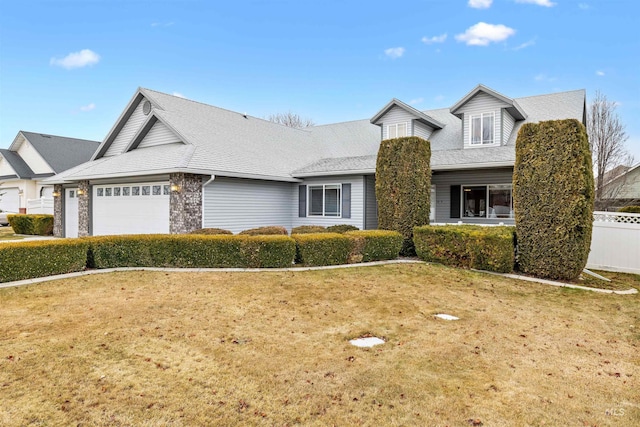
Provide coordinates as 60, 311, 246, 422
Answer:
15, 131, 100, 173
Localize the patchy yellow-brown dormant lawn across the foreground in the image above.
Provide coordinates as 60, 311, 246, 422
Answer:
0, 264, 640, 426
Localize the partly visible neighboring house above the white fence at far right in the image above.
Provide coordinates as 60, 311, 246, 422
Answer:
598, 163, 640, 211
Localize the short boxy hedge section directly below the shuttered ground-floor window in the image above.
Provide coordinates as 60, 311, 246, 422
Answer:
292, 233, 352, 266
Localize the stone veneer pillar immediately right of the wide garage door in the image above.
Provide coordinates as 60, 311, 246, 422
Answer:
169, 173, 202, 234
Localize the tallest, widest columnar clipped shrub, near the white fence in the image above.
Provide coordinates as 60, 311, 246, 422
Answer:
513, 119, 594, 280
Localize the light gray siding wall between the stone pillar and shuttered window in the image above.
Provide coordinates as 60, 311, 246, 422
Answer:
202, 178, 297, 233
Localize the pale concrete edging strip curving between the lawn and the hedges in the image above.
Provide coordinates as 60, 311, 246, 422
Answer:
0, 259, 638, 295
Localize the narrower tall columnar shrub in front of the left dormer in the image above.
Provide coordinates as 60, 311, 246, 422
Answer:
376, 136, 431, 256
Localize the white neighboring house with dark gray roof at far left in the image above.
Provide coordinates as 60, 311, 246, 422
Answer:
0, 131, 100, 214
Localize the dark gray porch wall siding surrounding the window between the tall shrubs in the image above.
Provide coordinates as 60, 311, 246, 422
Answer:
431, 168, 514, 224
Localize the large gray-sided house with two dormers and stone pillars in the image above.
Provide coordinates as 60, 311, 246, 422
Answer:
47, 85, 586, 236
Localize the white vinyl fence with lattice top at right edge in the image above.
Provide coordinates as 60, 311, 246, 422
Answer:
587, 212, 640, 274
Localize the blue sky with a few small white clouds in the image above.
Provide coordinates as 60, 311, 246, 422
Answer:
0, 0, 640, 162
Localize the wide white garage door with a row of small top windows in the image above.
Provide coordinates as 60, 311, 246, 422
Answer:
93, 182, 170, 236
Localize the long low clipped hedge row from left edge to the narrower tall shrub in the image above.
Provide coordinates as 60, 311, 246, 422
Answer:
0, 230, 402, 282
